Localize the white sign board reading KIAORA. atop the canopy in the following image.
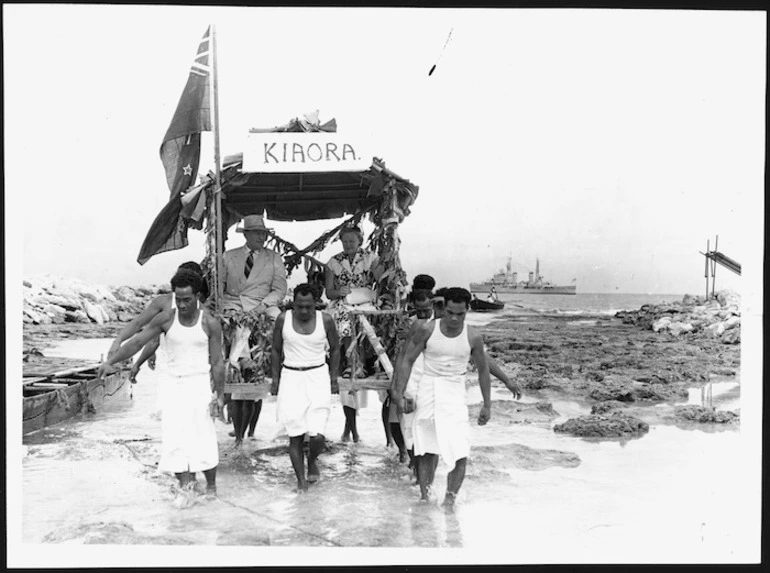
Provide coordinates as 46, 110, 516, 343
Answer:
241, 132, 372, 173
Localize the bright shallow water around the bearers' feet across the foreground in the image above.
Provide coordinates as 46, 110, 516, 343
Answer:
22, 340, 749, 563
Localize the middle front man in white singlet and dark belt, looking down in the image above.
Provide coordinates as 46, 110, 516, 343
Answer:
270, 283, 340, 493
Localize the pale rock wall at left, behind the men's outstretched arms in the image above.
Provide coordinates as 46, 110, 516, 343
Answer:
22, 275, 171, 324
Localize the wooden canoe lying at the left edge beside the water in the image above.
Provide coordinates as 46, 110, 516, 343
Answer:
22, 363, 131, 435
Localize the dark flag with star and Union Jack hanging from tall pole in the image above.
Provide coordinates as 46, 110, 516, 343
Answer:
137, 28, 211, 265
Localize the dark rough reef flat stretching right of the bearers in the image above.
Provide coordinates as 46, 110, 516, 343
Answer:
474, 297, 740, 437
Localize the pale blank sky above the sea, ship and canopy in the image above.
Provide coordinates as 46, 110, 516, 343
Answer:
3, 5, 766, 294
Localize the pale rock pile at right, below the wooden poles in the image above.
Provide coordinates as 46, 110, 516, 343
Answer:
615, 291, 741, 344
